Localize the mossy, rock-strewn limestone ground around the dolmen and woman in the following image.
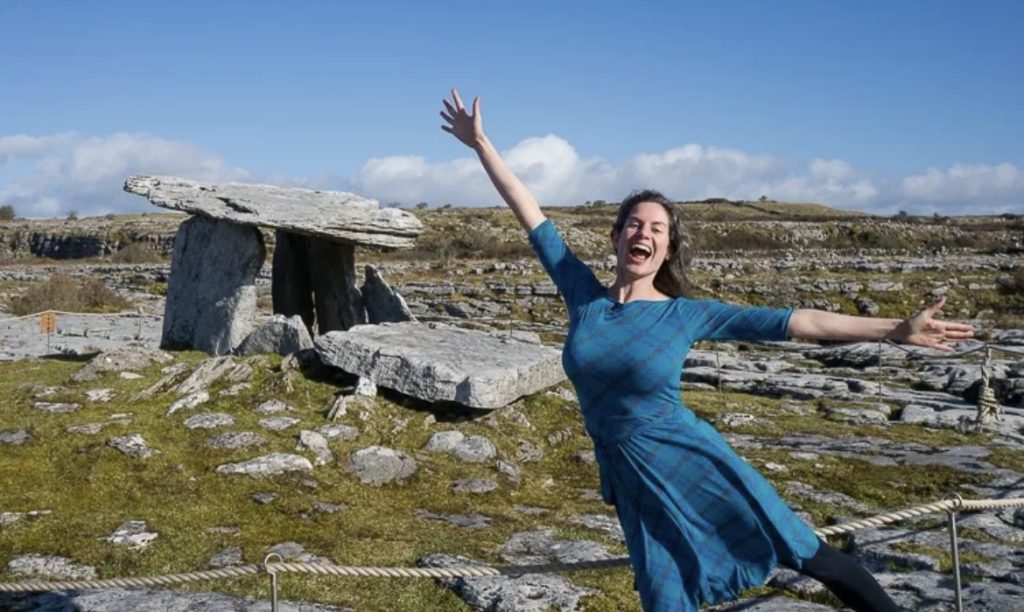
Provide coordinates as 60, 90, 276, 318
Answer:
0, 208, 1024, 611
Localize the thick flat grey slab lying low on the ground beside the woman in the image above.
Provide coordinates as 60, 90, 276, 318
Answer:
315, 322, 565, 408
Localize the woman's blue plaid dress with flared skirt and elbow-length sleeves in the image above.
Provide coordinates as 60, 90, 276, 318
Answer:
529, 220, 818, 612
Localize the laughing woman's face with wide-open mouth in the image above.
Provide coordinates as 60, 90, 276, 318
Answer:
615, 202, 671, 277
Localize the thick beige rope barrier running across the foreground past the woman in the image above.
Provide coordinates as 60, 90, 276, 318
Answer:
0, 496, 1024, 593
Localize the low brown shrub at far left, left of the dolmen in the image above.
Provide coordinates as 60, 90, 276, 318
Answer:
7, 272, 131, 316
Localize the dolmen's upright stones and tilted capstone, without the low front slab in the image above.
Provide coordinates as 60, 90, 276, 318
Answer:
124, 176, 423, 355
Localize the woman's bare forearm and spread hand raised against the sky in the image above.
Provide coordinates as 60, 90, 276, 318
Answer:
441, 89, 546, 232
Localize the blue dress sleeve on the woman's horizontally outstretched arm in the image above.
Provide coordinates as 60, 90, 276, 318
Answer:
692, 300, 793, 342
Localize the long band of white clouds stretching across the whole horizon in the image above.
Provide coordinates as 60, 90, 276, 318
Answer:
0, 133, 1024, 217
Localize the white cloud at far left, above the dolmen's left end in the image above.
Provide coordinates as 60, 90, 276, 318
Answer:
0, 133, 247, 217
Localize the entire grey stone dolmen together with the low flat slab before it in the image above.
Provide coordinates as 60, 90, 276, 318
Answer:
125, 176, 565, 409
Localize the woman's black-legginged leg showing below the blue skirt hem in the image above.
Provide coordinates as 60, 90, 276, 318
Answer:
798, 542, 901, 612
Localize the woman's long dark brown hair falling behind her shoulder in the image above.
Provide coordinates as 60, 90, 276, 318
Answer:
611, 189, 693, 298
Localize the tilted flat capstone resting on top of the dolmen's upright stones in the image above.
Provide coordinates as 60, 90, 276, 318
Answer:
124, 176, 423, 248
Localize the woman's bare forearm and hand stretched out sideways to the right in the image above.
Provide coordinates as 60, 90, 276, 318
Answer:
790, 298, 974, 351
